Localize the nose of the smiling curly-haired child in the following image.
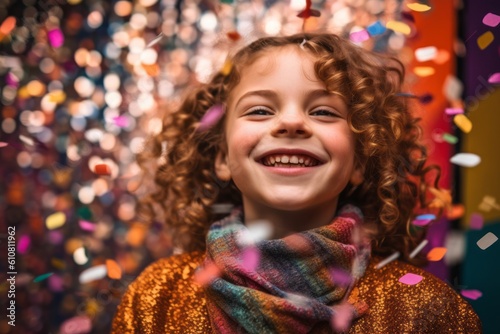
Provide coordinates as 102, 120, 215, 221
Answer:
272, 109, 312, 138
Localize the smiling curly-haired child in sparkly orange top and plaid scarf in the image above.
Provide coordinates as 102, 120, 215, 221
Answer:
113, 33, 480, 333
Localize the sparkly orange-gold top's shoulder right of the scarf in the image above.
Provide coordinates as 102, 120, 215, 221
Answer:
351, 257, 481, 333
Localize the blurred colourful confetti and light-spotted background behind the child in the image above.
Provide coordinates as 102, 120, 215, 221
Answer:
0, 0, 500, 333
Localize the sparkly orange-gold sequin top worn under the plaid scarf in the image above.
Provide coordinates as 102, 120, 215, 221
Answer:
112, 252, 481, 334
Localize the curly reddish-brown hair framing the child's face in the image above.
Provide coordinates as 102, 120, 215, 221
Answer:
138, 33, 439, 264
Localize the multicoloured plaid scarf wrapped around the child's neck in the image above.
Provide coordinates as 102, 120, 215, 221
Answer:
199, 205, 370, 334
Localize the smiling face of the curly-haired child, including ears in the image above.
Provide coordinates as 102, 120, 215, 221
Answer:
215, 45, 362, 232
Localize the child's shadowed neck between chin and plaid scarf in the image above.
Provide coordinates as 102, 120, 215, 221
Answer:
243, 200, 337, 239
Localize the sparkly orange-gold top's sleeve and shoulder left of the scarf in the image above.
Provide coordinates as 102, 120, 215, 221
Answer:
112, 252, 210, 334
